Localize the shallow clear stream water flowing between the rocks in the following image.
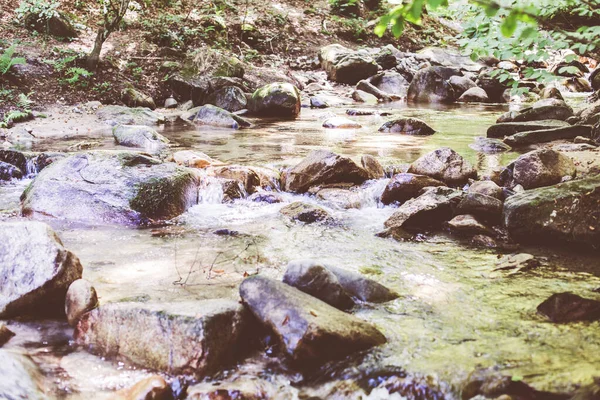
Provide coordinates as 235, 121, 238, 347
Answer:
0, 101, 600, 399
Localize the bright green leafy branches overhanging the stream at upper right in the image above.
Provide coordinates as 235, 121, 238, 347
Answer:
375, 0, 600, 80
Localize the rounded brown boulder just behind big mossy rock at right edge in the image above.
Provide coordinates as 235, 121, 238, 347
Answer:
512, 149, 576, 189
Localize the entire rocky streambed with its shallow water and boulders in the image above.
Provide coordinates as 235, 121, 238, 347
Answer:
0, 79, 600, 399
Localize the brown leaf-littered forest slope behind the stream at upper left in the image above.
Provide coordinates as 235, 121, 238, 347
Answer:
0, 0, 454, 116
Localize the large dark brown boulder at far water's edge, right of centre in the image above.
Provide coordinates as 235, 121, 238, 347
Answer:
407, 67, 460, 103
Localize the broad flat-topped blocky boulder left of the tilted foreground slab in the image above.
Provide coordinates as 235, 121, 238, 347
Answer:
74, 300, 251, 376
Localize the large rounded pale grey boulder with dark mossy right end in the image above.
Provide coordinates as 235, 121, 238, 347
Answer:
21, 151, 199, 225
